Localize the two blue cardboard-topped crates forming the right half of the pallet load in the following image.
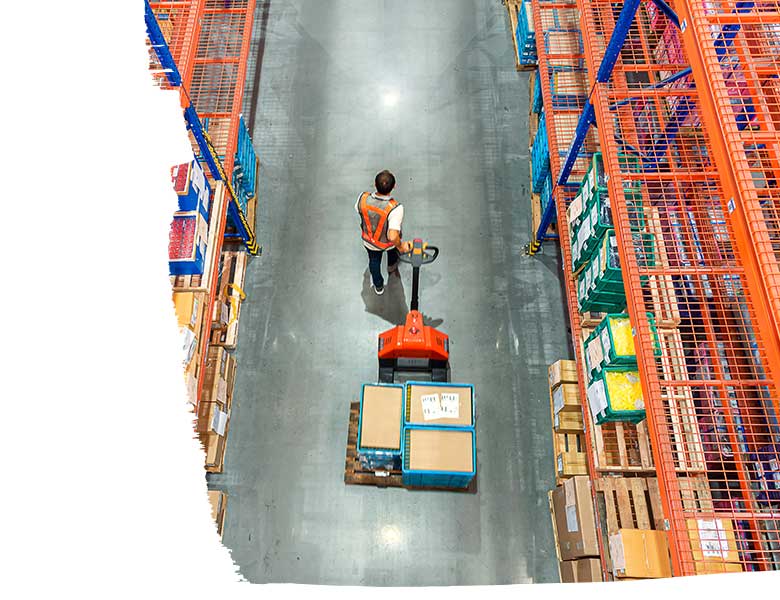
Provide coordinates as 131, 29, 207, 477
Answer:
401, 381, 477, 488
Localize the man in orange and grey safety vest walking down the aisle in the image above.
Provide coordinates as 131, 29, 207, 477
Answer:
355, 171, 412, 296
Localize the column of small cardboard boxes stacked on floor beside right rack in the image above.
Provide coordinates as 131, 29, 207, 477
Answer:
548, 360, 588, 483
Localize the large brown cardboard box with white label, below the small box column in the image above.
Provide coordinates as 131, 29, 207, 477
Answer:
552, 476, 599, 561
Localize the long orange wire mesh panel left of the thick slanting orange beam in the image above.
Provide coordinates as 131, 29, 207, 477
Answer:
578, 0, 780, 575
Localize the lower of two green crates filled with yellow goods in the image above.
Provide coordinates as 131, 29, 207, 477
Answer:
587, 366, 647, 425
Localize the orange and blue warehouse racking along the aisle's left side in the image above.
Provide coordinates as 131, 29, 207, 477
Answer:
145, 0, 260, 472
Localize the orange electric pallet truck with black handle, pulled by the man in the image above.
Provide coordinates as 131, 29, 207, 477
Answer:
378, 238, 450, 383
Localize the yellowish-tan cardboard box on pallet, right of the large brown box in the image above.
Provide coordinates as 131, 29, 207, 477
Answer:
609, 529, 672, 579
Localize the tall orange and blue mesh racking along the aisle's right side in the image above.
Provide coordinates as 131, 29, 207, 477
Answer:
529, 0, 780, 575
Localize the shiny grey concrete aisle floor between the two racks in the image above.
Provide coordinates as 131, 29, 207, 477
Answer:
209, 0, 569, 586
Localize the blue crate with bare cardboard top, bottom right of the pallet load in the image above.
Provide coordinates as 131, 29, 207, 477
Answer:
401, 425, 477, 488
